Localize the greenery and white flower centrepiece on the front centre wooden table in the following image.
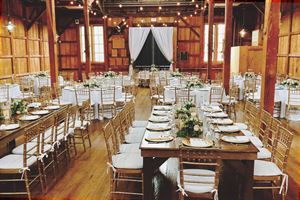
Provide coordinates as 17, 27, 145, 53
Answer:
175, 101, 203, 137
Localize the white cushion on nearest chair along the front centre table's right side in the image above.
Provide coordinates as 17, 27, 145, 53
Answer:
254, 160, 282, 176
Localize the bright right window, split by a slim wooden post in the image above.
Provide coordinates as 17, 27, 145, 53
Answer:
203, 24, 225, 62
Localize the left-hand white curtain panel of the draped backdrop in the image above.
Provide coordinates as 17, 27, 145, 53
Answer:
128, 27, 150, 76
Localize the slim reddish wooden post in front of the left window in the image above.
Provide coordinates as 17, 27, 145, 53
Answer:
83, 0, 91, 75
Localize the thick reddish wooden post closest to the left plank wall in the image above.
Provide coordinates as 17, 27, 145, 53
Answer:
46, 0, 58, 86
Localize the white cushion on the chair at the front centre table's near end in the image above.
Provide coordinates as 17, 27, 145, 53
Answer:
177, 169, 215, 194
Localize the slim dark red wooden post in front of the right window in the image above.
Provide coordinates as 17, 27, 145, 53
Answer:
207, 0, 215, 80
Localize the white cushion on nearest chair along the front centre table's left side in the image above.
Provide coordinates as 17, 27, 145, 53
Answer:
112, 153, 143, 169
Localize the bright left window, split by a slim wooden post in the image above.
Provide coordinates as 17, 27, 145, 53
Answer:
80, 26, 104, 62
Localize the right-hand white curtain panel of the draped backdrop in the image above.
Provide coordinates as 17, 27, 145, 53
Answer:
151, 27, 173, 71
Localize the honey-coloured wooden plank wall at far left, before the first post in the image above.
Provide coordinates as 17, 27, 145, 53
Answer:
0, 0, 50, 81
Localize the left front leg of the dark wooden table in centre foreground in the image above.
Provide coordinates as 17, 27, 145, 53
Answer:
143, 157, 153, 200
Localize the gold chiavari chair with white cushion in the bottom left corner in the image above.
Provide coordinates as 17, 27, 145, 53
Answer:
0, 123, 45, 200
